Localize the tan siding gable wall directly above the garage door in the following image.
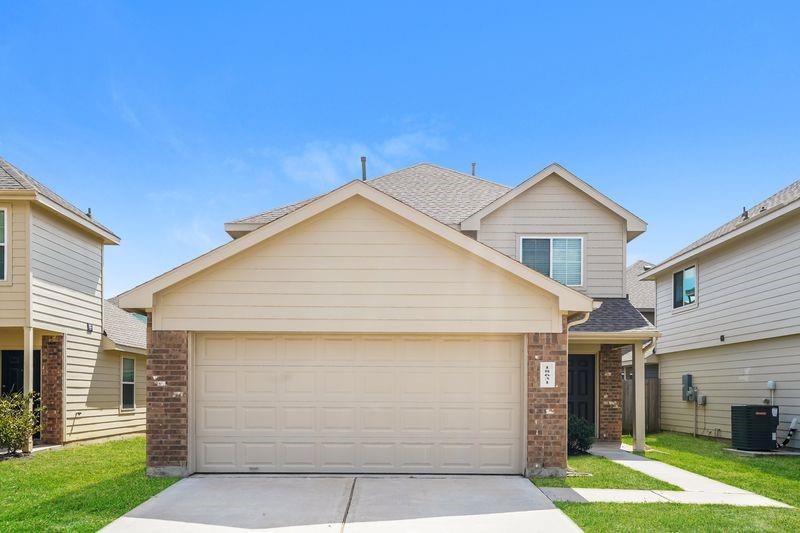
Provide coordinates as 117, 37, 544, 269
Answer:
154, 198, 561, 333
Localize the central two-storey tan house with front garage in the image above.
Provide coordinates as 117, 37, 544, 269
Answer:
120, 164, 657, 475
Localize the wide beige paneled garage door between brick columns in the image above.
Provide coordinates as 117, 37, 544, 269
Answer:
192, 334, 522, 473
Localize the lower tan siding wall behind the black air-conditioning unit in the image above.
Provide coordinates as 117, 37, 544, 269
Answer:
659, 335, 800, 447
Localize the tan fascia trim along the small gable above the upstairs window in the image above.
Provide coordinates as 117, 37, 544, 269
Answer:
461, 163, 647, 236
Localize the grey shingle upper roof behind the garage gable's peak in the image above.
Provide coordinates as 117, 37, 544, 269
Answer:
232, 163, 510, 228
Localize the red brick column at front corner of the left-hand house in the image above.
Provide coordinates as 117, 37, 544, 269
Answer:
40, 335, 64, 444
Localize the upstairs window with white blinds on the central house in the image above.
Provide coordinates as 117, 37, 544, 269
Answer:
520, 237, 583, 286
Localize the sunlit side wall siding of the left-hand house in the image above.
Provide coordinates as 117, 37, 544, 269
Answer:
30, 206, 144, 441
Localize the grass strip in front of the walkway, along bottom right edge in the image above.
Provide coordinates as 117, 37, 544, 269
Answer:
556, 502, 800, 533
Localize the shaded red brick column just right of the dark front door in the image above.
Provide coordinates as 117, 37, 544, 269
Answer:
597, 344, 622, 442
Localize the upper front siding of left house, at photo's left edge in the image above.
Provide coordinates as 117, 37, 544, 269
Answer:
0, 201, 30, 326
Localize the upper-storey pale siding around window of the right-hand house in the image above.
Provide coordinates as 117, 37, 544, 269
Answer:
656, 209, 800, 354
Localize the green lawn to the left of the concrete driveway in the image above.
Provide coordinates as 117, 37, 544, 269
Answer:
0, 437, 176, 531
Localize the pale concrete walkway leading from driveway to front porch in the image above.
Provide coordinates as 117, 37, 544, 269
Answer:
541, 444, 791, 507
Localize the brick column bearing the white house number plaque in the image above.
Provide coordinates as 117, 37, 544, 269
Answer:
525, 322, 568, 475
